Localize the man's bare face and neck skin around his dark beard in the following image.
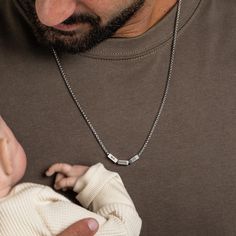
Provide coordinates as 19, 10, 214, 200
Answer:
36, 0, 177, 37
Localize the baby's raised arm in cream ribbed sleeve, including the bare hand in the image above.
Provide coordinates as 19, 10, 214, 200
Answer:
46, 163, 141, 236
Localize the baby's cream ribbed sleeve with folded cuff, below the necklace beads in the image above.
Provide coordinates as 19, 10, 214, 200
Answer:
74, 163, 141, 236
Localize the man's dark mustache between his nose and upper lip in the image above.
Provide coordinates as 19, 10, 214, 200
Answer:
62, 14, 101, 26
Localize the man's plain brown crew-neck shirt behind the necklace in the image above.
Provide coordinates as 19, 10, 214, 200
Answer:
0, 0, 236, 236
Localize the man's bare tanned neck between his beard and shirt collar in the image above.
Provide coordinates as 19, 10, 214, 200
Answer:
115, 0, 177, 38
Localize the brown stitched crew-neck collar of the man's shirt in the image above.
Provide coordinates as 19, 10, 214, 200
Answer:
13, 0, 201, 59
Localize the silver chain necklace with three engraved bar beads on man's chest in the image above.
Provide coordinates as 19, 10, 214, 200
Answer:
52, 0, 182, 166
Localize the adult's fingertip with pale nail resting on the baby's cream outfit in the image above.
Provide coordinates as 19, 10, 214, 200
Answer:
57, 219, 98, 236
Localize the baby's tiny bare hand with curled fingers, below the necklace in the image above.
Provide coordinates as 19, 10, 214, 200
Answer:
46, 163, 89, 191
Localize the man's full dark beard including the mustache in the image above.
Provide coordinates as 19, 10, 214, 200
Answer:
19, 0, 145, 54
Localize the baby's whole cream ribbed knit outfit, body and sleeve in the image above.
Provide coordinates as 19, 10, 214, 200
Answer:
0, 163, 141, 236
